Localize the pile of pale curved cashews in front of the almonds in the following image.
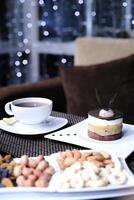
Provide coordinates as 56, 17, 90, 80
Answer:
57, 161, 127, 189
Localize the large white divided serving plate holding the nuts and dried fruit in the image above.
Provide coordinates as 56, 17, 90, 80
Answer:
0, 150, 134, 200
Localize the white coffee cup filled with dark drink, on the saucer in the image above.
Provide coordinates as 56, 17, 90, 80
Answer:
5, 97, 53, 124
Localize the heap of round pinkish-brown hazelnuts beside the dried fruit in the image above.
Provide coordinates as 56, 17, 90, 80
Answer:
13, 155, 55, 187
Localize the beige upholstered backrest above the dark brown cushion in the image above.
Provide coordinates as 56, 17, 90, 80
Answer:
74, 37, 134, 66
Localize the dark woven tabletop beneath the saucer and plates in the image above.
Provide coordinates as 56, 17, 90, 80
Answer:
0, 111, 134, 200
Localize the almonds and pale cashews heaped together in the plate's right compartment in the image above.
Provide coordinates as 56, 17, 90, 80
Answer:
57, 150, 127, 189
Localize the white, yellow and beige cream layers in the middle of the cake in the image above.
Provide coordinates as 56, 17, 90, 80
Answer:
88, 116, 123, 136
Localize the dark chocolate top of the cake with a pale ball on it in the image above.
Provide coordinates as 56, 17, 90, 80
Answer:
89, 108, 123, 120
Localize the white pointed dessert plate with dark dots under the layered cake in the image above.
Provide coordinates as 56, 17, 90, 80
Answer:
44, 119, 134, 158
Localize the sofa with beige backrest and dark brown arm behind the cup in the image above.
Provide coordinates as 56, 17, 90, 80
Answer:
0, 37, 134, 122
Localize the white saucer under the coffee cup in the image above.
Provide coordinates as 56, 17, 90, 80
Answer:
0, 116, 68, 135
